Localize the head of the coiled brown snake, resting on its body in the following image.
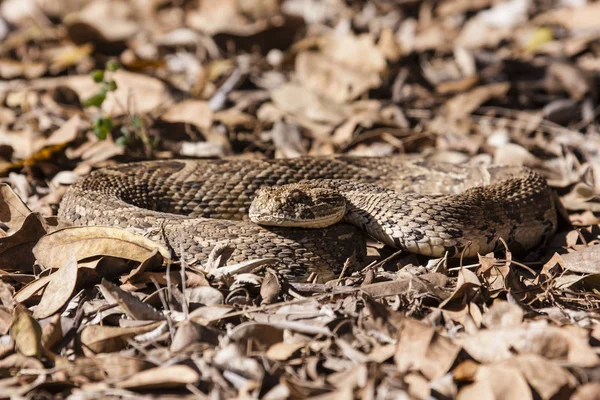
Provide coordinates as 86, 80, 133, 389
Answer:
248, 182, 346, 228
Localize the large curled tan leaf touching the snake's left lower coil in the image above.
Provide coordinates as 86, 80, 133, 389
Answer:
33, 226, 170, 268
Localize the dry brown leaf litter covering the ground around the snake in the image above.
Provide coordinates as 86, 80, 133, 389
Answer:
0, 0, 600, 400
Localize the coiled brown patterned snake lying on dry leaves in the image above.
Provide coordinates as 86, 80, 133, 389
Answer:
58, 155, 557, 280
